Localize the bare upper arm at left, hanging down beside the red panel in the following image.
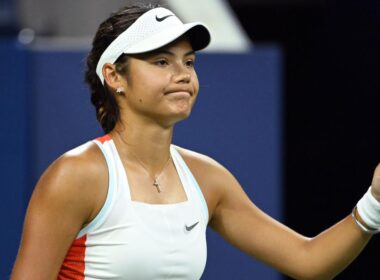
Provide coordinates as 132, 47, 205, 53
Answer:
12, 144, 104, 279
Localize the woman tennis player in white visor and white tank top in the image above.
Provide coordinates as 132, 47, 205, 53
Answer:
11, 3, 380, 280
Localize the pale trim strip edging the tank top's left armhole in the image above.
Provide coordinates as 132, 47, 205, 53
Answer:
77, 140, 116, 239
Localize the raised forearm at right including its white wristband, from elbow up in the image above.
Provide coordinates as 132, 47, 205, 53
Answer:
306, 184, 380, 279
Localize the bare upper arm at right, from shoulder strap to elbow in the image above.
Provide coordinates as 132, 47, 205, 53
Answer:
182, 152, 309, 275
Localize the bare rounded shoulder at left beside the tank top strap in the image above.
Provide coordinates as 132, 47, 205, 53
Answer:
31, 142, 108, 224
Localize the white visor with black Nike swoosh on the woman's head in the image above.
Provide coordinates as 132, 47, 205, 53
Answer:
96, 8, 211, 84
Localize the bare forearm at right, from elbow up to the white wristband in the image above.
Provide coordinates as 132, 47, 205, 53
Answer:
305, 215, 371, 279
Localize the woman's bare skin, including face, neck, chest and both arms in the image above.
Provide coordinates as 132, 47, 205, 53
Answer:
11, 38, 380, 280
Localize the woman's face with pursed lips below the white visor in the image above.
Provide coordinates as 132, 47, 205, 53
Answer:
120, 38, 199, 125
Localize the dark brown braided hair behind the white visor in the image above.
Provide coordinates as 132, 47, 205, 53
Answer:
85, 4, 158, 133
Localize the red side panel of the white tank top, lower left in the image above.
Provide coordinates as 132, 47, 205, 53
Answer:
57, 235, 87, 280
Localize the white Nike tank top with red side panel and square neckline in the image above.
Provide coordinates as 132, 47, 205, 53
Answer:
58, 135, 208, 280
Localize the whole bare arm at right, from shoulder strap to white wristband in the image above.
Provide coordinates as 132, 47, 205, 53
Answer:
182, 148, 370, 279
